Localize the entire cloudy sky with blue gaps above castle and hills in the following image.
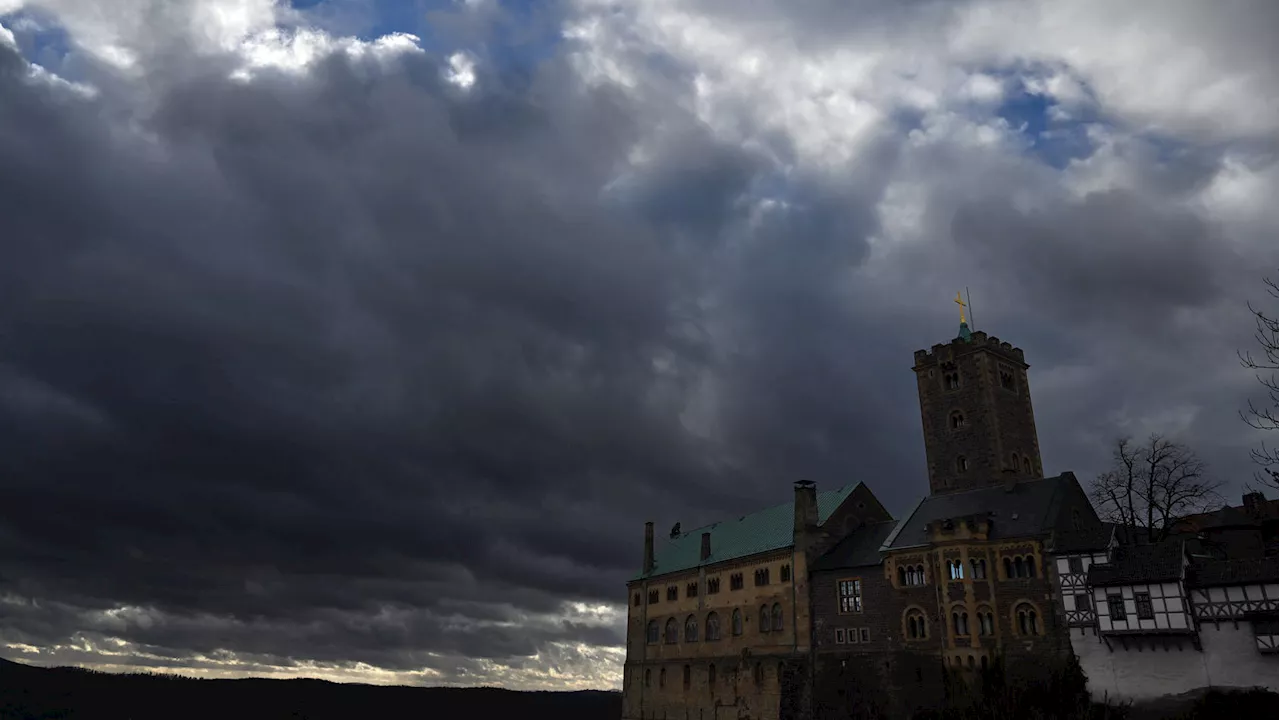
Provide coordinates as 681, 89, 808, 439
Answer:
0, 0, 1280, 689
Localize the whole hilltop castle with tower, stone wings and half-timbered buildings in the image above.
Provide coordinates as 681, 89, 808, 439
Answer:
623, 310, 1280, 720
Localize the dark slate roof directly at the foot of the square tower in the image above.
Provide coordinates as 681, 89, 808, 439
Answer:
882, 473, 1075, 550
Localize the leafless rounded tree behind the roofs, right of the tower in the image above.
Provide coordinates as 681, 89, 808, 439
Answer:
1089, 434, 1222, 542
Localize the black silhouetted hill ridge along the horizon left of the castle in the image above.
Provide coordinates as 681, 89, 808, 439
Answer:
0, 660, 622, 720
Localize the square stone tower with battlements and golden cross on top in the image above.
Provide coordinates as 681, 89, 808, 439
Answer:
913, 316, 1043, 495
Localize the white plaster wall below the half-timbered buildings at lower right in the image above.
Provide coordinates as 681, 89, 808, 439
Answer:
1071, 621, 1280, 701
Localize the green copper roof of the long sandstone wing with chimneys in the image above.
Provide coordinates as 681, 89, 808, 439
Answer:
631, 483, 860, 580
